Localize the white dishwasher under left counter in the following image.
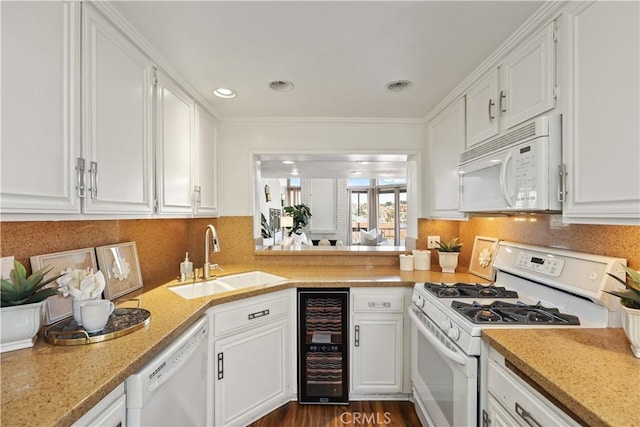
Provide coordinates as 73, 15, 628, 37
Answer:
126, 316, 213, 426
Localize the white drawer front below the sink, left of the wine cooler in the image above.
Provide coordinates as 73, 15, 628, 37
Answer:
211, 294, 291, 336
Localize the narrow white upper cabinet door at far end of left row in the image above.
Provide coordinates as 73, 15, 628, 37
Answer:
194, 105, 218, 216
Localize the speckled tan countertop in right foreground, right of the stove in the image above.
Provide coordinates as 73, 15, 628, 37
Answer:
482, 328, 640, 427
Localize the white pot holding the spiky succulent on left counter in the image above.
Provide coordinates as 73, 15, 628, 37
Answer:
0, 301, 46, 353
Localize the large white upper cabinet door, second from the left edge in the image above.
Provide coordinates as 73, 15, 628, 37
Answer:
82, 3, 153, 213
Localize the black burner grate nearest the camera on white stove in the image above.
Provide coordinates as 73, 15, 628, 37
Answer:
451, 301, 580, 325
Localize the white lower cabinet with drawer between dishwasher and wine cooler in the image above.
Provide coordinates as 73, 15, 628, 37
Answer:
209, 290, 295, 426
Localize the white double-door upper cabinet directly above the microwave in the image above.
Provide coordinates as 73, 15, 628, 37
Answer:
466, 22, 555, 148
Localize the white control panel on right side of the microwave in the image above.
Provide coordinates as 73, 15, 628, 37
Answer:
513, 144, 539, 207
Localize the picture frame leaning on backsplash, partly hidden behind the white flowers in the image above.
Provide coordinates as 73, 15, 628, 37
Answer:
30, 248, 98, 325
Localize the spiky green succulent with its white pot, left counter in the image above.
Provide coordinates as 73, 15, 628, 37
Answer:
0, 261, 62, 352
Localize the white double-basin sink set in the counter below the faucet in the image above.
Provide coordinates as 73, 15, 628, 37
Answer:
169, 271, 287, 299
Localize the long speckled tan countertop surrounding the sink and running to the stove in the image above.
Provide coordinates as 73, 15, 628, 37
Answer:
0, 265, 481, 426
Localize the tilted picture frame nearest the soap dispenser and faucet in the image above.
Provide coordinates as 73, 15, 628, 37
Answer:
96, 242, 142, 300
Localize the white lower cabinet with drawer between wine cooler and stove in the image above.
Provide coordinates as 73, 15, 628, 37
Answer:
350, 288, 411, 400
